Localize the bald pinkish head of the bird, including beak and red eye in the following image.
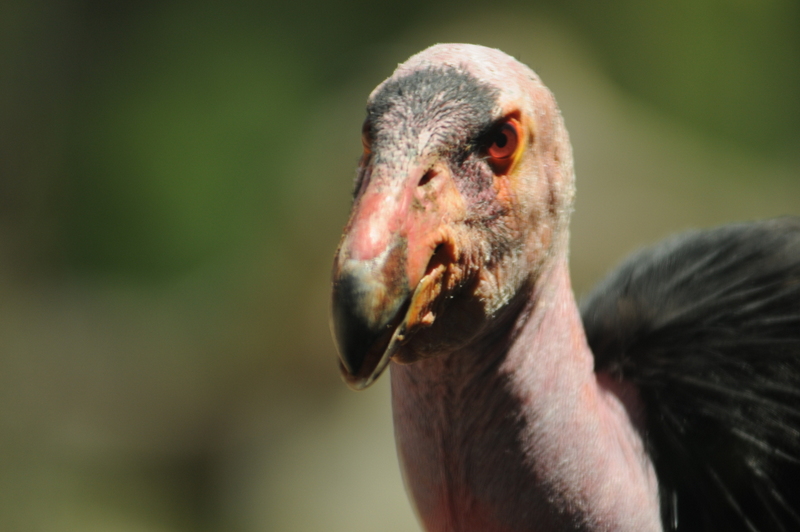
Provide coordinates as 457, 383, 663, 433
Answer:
332, 44, 574, 389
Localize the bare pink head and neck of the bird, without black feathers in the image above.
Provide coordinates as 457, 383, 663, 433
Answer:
333, 45, 660, 532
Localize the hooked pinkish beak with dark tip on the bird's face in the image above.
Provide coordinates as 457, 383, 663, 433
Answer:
331, 160, 463, 390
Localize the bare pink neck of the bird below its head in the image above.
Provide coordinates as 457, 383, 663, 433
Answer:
391, 260, 662, 532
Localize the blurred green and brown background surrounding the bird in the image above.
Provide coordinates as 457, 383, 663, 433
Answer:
0, 0, 800, 532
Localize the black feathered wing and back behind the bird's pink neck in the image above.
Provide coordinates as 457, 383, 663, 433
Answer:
582, 218, 800, 532
